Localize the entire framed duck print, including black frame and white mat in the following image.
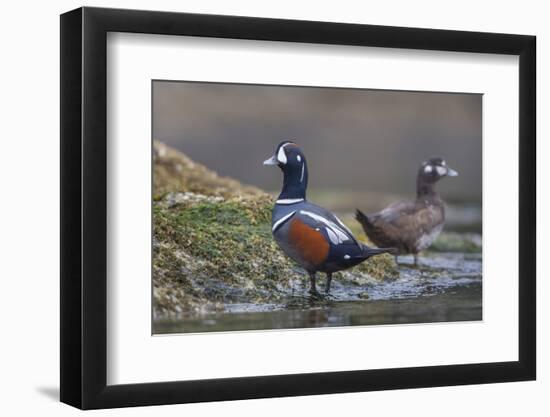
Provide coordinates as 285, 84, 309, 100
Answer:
61, 8, 536, 409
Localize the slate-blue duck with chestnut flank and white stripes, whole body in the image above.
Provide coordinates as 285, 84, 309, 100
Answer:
264, 142, 393, 296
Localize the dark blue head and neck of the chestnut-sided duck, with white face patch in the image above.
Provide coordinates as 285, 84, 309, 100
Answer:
264, 141, 308, 198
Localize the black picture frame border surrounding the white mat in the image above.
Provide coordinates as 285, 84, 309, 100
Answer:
60, 7, 536, 409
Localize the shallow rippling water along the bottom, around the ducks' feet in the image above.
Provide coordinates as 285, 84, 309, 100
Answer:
153, 253, 482, 334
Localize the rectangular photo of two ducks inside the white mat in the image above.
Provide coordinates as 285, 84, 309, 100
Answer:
152, 80, 483, 334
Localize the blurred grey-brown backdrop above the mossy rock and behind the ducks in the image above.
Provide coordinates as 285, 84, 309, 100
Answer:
153, 81, 482, 232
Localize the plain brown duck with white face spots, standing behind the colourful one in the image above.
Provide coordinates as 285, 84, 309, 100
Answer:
355, 158, 458, 265
